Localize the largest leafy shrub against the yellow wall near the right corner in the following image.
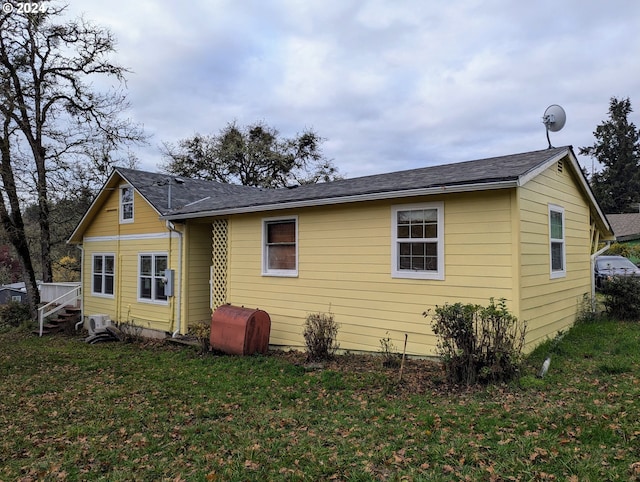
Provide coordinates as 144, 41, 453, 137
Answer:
423, 298, 526, 385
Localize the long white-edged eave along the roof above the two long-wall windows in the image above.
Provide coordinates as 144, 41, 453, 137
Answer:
160, 179, 518, 220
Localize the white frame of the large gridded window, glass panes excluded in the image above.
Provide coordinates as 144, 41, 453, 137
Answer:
391, 202, 444, 280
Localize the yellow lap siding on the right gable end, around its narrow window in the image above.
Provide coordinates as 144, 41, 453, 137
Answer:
519, 164, 590, 347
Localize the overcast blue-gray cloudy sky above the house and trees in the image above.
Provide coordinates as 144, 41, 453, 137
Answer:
69, 0, 640, 177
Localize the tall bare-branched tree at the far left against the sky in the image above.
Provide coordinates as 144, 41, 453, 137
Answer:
0, 0, 144, 316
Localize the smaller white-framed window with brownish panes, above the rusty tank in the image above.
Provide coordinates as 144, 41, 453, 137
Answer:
262, 217, 298, 276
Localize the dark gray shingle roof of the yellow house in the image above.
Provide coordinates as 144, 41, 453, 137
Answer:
151, 147, 571, 219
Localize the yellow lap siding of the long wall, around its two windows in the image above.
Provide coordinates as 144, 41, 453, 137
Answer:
227, 191, 513, 355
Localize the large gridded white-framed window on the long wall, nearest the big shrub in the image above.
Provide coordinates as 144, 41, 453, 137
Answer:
391, 202, 444, 280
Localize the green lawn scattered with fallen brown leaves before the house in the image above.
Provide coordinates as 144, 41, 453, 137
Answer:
0, 322, 640, 481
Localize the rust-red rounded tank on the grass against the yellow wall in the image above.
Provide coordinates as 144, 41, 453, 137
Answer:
209, 305, 271, 355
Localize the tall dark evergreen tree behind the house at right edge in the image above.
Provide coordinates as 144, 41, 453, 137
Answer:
579, 97, 640, 214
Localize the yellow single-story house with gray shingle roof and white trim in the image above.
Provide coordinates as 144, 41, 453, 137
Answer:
70, 147, 613, 355
